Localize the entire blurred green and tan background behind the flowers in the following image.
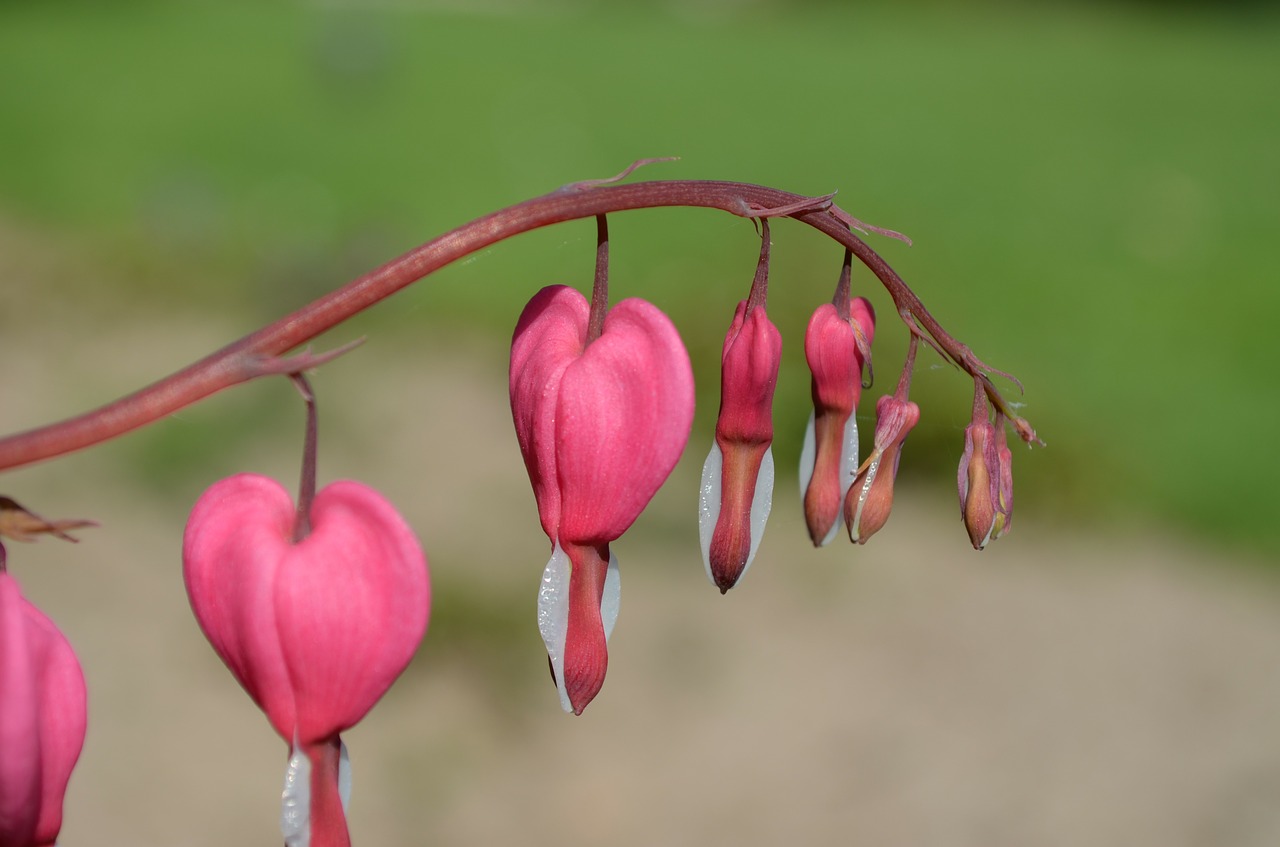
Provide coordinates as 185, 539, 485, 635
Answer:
0, 0, 1280, 847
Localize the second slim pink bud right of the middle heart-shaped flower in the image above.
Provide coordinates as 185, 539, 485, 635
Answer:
800, 297, 876, 546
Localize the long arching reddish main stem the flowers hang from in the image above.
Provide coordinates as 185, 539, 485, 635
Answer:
0, 179, 1034, 470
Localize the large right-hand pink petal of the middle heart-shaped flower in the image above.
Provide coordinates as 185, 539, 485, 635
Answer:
556, 299, 694, 544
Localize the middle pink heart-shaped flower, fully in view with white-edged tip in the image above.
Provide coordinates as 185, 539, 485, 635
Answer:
511, 285, 694, 714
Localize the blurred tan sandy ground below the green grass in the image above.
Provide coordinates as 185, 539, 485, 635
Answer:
0, 315, 1280, 847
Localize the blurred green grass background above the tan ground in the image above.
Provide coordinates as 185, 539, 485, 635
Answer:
0, 0, 1280, 554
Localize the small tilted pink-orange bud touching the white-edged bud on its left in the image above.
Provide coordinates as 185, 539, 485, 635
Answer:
845, 394, 920, 544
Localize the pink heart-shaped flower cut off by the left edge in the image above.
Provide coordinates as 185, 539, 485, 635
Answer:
0, 570, 86, 847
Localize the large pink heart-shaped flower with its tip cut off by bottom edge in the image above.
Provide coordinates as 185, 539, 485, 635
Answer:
183, 473, 430, 847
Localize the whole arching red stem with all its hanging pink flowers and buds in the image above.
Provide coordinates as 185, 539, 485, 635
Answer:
0, 171, 1037, 847
